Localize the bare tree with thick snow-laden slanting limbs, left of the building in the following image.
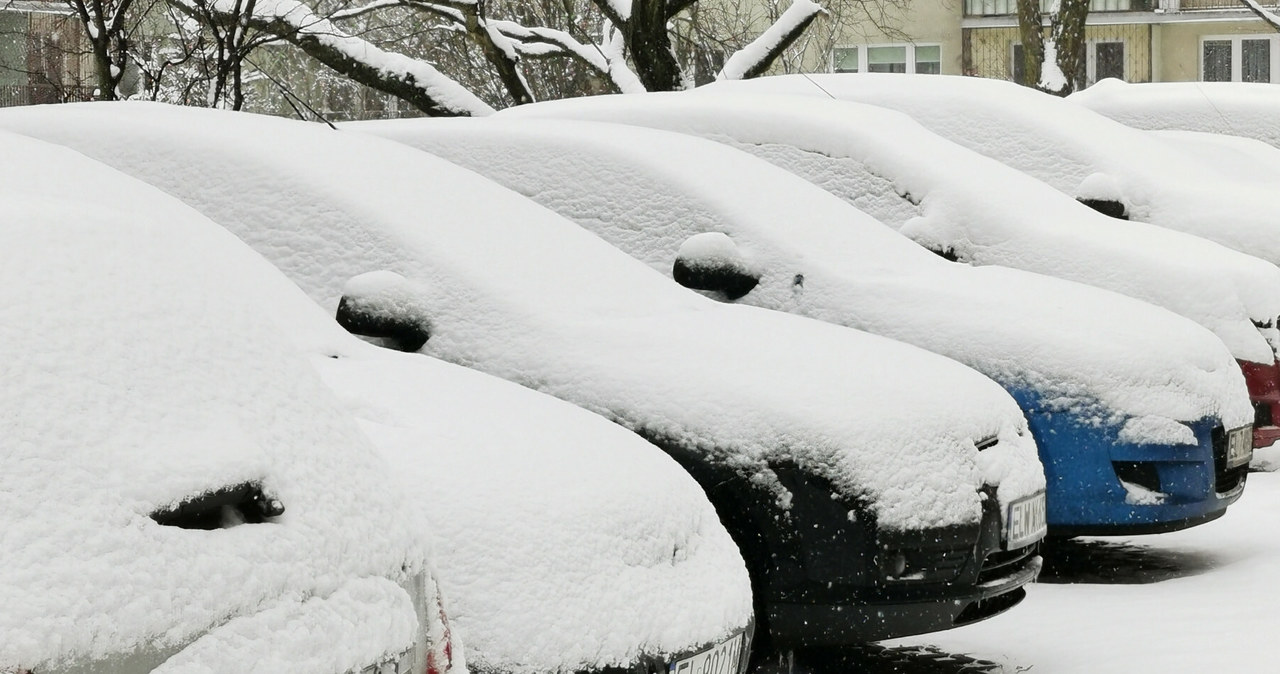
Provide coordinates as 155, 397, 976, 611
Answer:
168, 0, 822, 115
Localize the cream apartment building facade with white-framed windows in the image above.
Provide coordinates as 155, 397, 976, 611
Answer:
812, 0, 1280, 84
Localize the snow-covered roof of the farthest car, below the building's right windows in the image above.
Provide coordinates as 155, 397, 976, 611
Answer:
1066, 78, 1280, 147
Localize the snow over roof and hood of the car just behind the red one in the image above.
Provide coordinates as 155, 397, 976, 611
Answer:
707, 73, 1280, 271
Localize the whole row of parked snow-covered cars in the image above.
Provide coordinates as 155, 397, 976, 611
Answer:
0, 75, 1280, 674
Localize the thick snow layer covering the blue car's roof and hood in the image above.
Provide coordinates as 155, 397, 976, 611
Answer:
353, 116, 1253, 444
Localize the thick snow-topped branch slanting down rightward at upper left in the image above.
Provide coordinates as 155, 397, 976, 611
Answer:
168, 0, 493, 116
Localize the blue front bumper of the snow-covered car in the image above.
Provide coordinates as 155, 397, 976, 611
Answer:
1014, 393, 1248, 536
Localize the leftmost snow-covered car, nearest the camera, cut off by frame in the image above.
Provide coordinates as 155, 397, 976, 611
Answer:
0, 133, 465, 674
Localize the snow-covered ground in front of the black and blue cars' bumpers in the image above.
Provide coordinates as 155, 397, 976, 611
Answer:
887, 473, 1280, 674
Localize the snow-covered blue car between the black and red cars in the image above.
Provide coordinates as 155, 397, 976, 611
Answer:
366, 115, 1252, 535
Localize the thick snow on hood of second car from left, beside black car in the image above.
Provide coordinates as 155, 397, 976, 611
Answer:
316, 353, 751, 674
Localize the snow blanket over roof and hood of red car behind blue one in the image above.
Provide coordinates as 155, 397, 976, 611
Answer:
498, 88, 1280, 362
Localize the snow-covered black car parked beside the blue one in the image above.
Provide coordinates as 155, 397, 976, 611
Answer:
0, 104, 1044, 652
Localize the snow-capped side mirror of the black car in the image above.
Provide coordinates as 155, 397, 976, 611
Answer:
337, 271, 431, 352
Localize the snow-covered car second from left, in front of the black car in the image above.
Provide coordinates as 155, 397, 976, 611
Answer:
0, 129, 751, 674
